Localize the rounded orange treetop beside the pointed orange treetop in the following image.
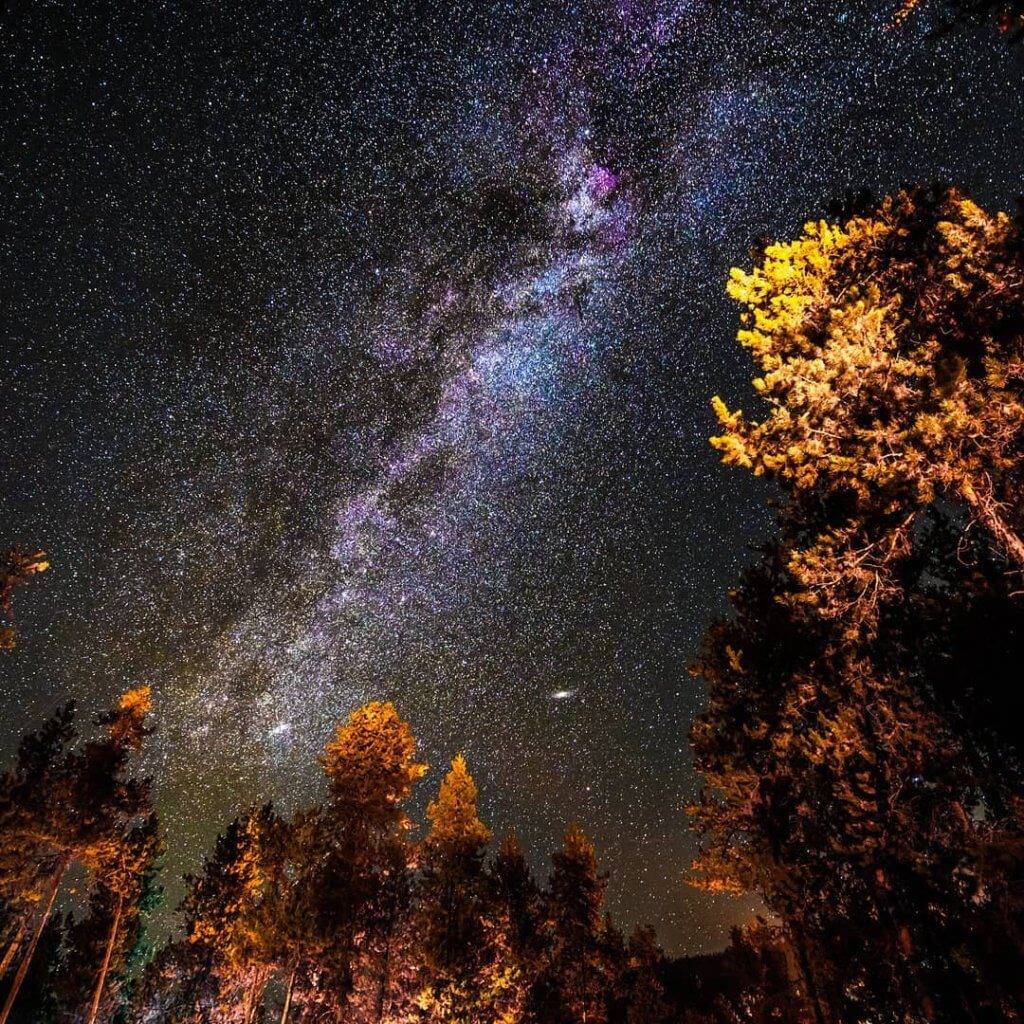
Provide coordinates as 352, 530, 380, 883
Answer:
321, 700, 427, 810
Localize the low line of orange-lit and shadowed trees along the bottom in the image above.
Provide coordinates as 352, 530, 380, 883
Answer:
0, 691, 807, 1024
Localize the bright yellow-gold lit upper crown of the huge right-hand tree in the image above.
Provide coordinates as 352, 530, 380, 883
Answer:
712, 190, 1024, 566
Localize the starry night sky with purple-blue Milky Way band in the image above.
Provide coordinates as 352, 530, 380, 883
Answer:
0, 0, 1024, 951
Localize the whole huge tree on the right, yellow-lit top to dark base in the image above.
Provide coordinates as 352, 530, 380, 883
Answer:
692, 193, 1024, 1024
